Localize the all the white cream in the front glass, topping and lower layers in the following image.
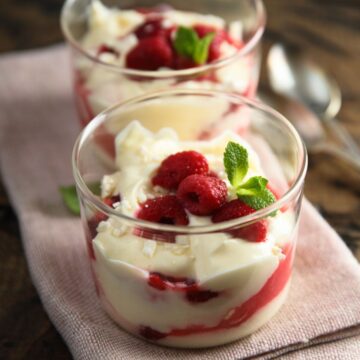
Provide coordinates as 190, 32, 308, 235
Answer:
92, 121, 295, 346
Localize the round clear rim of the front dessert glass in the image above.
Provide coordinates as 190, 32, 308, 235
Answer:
72, 89, 308, 234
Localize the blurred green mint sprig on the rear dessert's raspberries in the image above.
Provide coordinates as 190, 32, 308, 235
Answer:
174, 26, 215, 65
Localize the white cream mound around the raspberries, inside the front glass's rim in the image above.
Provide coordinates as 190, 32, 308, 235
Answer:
102, 121, 262, 217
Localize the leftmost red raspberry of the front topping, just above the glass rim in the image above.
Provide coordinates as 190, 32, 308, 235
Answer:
137, 195, 189, 225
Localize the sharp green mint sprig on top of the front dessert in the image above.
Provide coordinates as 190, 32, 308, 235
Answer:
224, 141, 276, 210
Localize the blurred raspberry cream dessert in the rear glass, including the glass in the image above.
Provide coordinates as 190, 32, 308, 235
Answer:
61, 0, 265, 126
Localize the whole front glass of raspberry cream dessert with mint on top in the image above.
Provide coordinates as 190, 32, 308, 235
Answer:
73, 89, 307, 348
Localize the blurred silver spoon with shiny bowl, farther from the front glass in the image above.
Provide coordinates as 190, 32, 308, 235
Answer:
267, 43, 360, 158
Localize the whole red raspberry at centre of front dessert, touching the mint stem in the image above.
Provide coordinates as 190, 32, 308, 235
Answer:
176, 175, 227, 215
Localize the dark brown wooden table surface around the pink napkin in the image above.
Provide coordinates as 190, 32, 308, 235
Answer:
0, 0, 360, 360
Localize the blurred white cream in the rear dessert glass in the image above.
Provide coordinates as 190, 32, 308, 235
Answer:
75, 0, 259, 123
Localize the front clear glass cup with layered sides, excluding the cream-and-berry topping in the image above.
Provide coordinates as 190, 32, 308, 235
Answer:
73, 90, 307, 348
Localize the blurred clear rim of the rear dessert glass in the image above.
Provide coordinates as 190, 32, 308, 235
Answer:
60, 0, 266, 79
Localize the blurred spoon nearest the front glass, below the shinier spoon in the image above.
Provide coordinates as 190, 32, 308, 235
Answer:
259, 90, 360, 170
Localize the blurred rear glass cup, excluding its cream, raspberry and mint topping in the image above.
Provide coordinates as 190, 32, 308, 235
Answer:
61, 0, 265, 126
